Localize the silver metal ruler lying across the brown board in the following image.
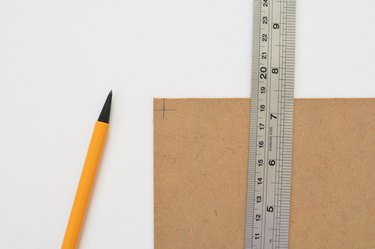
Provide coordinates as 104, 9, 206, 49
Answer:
245, 0, 296, 249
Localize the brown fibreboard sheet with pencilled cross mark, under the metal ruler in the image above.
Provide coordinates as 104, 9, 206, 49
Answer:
154, 99, 375, 249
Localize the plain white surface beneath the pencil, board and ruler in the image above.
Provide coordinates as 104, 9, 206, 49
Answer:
0, 0, 375, 249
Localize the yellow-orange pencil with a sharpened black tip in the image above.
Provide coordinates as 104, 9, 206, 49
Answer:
61, 91, 112, 249
